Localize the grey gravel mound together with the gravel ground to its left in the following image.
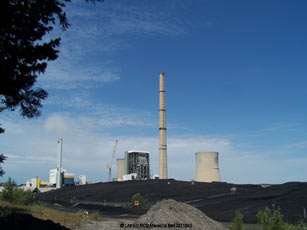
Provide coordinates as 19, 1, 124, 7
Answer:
75, 199, 226, 230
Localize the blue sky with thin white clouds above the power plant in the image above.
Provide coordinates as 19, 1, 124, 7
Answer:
0, 0, 307, 183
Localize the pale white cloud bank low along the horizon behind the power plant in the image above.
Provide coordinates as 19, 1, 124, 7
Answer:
0, 114, 307, 186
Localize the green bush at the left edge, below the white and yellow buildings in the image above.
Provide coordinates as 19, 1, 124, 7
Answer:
0, 178, 34, 205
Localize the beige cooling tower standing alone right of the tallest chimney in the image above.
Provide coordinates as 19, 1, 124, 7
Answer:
195, 152, 221, 182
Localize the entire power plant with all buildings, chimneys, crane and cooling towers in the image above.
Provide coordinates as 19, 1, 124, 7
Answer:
27, 73, 221, 188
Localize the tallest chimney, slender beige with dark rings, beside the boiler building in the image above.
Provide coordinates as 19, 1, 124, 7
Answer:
159, 73, 167, 179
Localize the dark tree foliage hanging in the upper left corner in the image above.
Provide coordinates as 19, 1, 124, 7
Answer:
0, 0, 103, 175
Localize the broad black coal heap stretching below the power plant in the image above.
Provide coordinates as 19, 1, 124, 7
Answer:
36, 179, 307, 223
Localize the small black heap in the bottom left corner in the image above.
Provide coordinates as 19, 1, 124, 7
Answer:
0, 213, 69, 230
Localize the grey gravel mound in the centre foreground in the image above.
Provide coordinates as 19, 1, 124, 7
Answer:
135, 199, 226, 230
